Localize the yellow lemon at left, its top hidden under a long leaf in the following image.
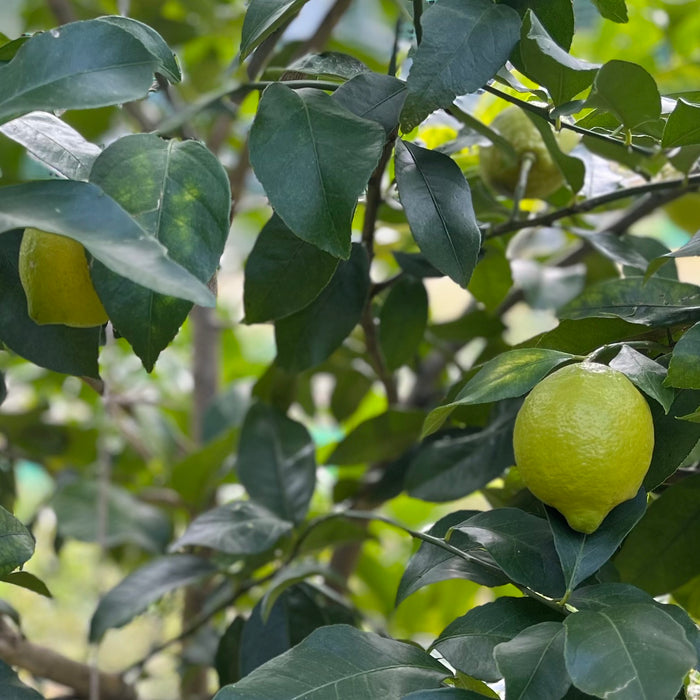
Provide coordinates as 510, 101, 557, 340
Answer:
19, 228, 108, 328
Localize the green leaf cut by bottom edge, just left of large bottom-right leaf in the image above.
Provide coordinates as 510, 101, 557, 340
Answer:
493, 622, 571, 700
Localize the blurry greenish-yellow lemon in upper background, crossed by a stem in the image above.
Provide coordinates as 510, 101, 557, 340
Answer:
479, 106, 577, 197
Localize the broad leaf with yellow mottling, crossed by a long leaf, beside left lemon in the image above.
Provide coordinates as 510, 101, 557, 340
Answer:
90, 134, 231, 371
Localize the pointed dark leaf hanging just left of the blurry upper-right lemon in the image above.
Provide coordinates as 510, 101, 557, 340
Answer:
396, 141, 481, 287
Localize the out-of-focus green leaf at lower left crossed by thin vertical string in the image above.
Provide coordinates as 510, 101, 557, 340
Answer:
51, 480, 172, 553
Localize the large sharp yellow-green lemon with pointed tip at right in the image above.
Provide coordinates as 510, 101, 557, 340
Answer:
513, 362, 654, 533
